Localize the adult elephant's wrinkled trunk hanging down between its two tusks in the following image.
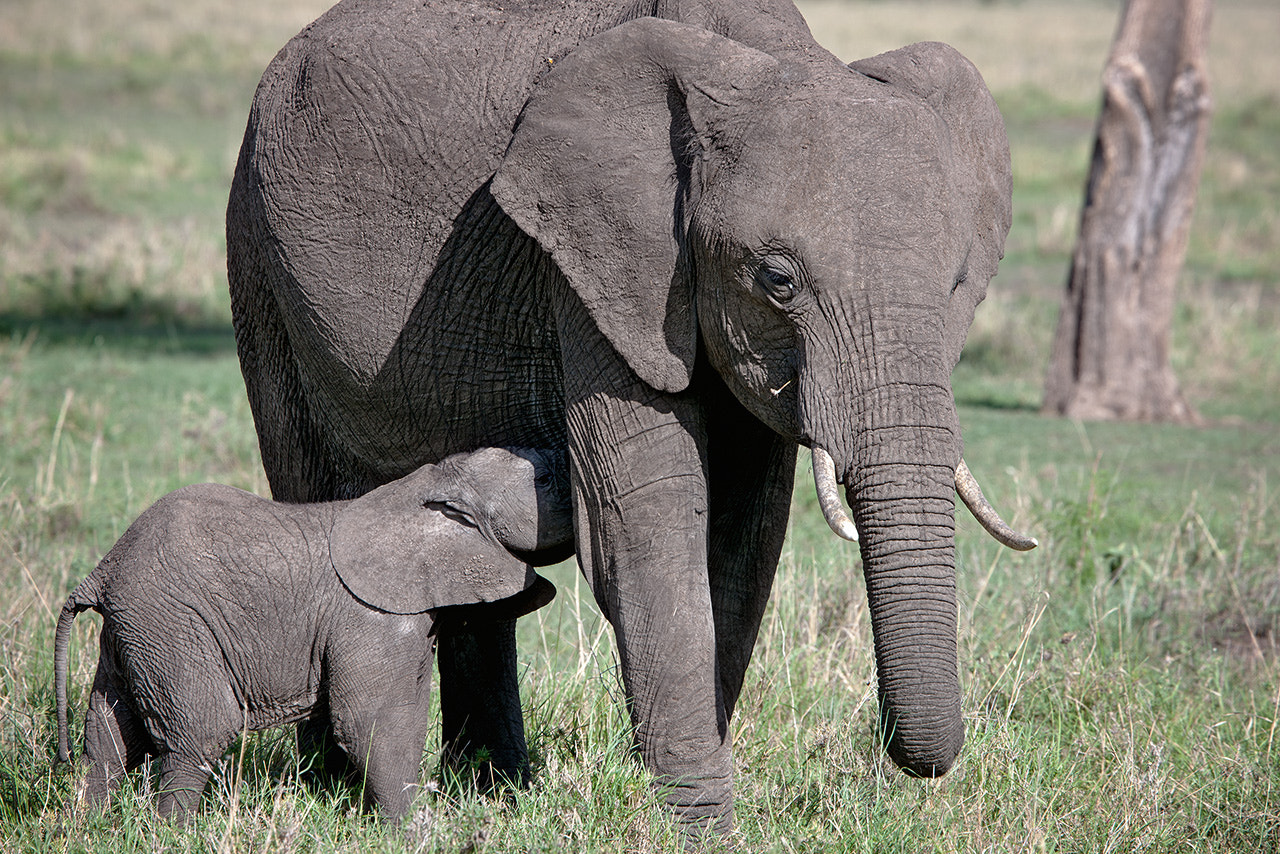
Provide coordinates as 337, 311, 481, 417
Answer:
806, 374, 964, 777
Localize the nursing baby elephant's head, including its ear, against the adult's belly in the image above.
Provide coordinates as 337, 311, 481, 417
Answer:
329, 448, 573, 618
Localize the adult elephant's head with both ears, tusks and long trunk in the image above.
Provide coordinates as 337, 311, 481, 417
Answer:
492, 19, 1030, 776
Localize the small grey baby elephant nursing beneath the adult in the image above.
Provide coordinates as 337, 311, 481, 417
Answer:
54, 448, 572, 821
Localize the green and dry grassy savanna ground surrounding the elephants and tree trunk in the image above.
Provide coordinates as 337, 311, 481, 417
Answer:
0, 0, 1280, 853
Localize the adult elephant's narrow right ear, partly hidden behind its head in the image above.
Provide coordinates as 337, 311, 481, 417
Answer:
849, 42, 1012, 365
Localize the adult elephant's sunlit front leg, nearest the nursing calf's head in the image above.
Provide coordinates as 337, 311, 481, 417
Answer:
567, 367, 733, 831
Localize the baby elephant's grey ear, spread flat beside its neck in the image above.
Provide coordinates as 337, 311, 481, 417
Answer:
329, 466, 538, 613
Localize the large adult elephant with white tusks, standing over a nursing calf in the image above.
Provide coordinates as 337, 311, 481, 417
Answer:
227, 0, 1029, 827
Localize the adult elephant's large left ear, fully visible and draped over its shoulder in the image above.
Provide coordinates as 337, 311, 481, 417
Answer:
492, 18, 777, 392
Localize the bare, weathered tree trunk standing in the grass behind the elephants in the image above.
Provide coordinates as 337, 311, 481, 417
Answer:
1043, 0, 1212, 421
